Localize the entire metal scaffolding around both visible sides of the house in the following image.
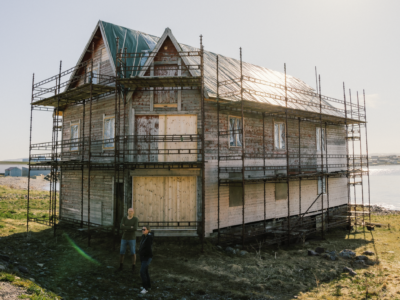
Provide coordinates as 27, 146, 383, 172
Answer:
27, 37, 371, 245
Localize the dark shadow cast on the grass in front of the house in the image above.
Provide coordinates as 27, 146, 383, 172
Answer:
0, 223, 382, 299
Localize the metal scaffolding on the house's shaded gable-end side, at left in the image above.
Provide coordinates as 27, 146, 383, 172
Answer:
27, 38, 205, 246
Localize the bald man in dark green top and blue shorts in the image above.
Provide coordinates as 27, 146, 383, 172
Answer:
117, 208, 139, 272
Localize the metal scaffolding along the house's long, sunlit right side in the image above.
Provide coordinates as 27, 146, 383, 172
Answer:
216, 49, 371, 244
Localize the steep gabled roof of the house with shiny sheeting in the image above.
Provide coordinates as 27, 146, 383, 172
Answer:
70, 21, 344, 117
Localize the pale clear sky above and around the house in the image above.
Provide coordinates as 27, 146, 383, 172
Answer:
0, 0, 400, 160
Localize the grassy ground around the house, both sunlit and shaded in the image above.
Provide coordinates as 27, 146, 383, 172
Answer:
0, 186, 400, 300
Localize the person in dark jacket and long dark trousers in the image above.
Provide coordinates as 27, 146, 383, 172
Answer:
139, 225, 153, 294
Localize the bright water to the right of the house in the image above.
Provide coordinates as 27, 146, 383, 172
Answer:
351, 165, 400, 210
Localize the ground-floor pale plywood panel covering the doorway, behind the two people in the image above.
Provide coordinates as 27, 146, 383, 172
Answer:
132, 176, 196, 227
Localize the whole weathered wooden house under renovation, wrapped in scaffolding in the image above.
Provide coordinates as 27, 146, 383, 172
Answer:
27, 21, 369, 244
